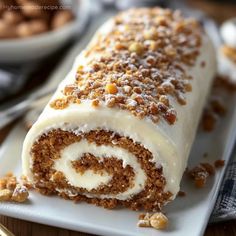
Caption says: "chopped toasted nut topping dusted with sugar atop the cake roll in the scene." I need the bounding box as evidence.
[50,8,202,124]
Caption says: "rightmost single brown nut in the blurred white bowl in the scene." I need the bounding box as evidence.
[52,10,74,29]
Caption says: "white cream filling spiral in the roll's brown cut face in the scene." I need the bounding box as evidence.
[53,140,147,200]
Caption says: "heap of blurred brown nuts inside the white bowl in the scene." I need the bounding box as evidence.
[0,0,74,39]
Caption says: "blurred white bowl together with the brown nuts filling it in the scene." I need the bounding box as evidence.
[0,0,90,63]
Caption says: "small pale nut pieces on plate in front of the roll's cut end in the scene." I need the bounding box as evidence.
[138,212,168,230]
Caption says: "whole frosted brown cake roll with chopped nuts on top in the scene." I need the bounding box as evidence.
[22,8,216,211]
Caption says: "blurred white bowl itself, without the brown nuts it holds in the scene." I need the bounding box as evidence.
[0,0,90,63]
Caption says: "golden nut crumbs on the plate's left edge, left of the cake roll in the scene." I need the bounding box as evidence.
[0,173,29,202]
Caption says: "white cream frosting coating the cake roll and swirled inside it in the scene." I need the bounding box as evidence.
[22,18,216,199]
